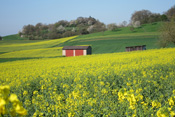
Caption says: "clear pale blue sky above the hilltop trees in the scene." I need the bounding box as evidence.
[0,0,175,36]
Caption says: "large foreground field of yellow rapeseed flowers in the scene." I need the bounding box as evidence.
[0,48,175,117]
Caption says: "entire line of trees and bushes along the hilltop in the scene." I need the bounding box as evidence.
[19,7,175,40]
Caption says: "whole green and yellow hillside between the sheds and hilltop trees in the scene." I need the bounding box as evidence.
[0,22,174,61]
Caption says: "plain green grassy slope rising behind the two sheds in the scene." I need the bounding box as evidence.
[62,22,172,54]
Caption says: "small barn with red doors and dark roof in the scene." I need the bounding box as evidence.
[62,46,92,57]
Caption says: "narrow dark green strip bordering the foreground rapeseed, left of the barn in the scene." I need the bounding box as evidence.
[0,56,63,63]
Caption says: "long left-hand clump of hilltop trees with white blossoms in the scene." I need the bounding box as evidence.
[19,17,106,40]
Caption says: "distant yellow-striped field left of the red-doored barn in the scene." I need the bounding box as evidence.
[0,36,76,62]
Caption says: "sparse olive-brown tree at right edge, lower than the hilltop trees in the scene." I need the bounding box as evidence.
[159,19,175,47]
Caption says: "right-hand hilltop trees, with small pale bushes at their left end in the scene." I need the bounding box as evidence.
[107,6,175,30]
